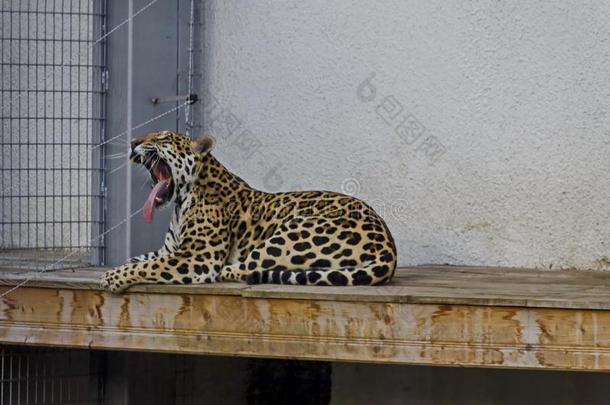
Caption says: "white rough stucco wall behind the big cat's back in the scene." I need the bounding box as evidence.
[204,0,610,269]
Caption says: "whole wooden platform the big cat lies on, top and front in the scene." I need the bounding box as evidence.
[0,266,610,371]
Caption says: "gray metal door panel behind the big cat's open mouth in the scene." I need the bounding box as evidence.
[105,0,203,265]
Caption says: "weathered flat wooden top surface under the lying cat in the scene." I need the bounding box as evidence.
[0,266,610,310]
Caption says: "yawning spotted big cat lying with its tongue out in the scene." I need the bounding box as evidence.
[101,131,396,292]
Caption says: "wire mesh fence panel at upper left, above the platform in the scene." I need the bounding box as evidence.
[0,0,106,267]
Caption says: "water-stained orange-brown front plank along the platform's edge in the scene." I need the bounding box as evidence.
[0,287,610,371]
